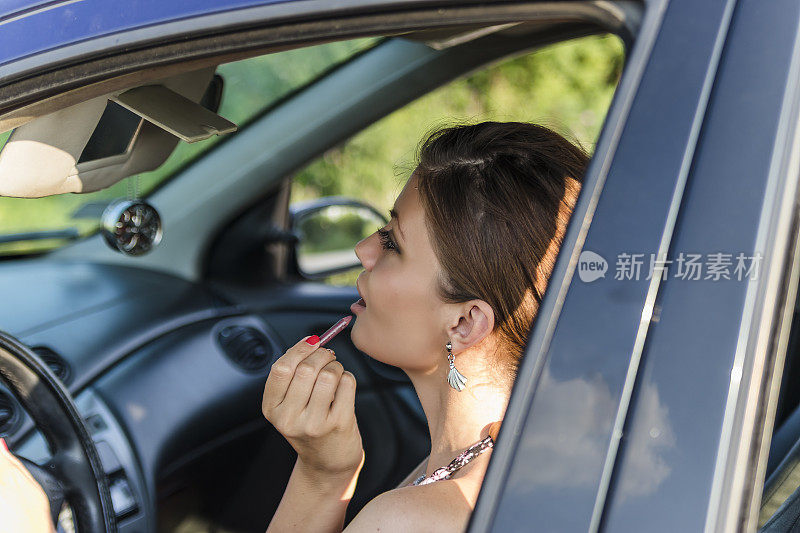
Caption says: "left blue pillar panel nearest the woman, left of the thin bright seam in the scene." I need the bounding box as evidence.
[468,0,752,531]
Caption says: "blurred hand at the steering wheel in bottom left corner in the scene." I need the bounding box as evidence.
[0,439,55,533]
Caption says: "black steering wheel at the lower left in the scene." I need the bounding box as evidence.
[0,331,117,533]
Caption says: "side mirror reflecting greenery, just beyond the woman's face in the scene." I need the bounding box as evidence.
[291,196,388,279]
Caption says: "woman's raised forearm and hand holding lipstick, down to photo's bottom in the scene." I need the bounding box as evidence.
[261,335,365,533]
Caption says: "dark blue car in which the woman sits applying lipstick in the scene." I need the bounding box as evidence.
[0,0,800,533]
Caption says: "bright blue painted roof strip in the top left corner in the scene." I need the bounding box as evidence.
[0,0,302,69]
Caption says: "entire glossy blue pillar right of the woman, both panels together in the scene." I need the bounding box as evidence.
[472,0,800,532]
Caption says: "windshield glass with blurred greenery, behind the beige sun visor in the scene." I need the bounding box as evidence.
[0,38,379,255]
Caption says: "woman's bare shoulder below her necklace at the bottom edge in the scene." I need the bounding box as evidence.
[344,480,473,533]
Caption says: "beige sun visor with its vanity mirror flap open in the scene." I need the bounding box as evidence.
[0,68,236,198]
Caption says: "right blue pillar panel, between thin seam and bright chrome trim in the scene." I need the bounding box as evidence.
[605,0,800,532]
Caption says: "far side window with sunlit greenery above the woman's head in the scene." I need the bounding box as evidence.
[292,34,625,285]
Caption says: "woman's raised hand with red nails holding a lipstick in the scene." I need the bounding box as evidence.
[261,335,364,476]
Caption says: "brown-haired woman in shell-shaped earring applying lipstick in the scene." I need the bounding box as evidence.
[0,122,588,533]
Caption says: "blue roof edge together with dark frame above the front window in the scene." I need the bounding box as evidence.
[0,0,614,87]
